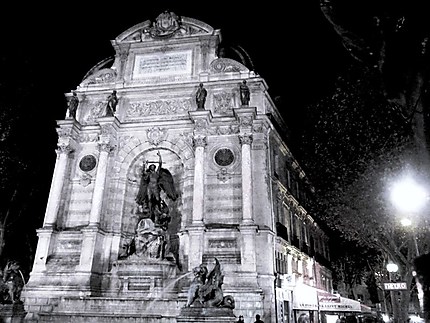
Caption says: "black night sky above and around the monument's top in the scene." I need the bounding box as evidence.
[0,0,347,218]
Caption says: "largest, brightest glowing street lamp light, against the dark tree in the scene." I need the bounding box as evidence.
[391,178,428,212]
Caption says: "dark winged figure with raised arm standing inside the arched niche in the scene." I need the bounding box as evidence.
[135,151,178,230]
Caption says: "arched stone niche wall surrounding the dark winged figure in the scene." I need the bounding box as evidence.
[106,137,194,261]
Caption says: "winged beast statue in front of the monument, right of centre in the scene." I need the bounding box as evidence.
[185,258,235,309]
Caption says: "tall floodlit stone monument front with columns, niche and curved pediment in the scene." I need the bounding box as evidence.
[23,11,277,322]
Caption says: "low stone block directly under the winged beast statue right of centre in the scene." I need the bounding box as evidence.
[176,307,237,323]
